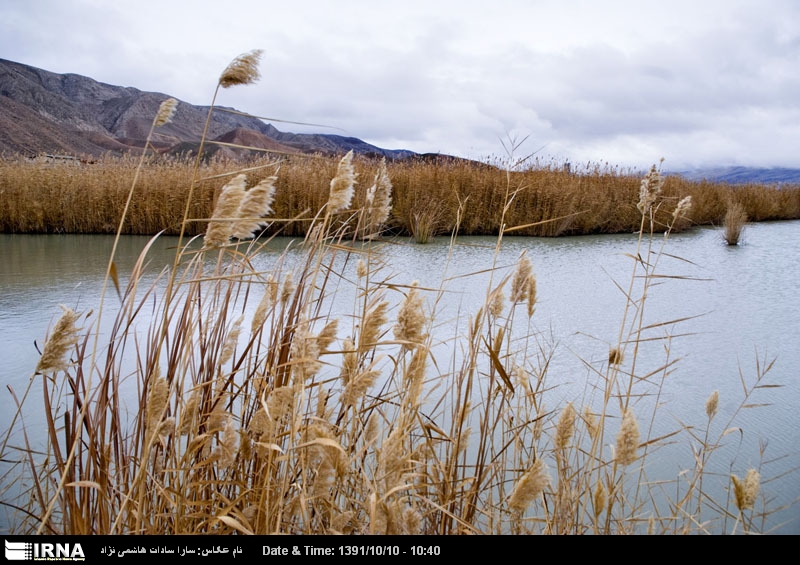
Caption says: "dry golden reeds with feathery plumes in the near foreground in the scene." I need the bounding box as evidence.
[0,49,792,535]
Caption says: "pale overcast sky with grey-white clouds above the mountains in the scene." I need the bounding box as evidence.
[0,0,800,171]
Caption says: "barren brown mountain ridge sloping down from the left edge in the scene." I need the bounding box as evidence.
[0,59,415,159]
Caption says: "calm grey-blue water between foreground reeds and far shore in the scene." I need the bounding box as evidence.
[0,222,800,534]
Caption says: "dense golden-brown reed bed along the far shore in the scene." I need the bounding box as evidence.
[0,154,800,241]
